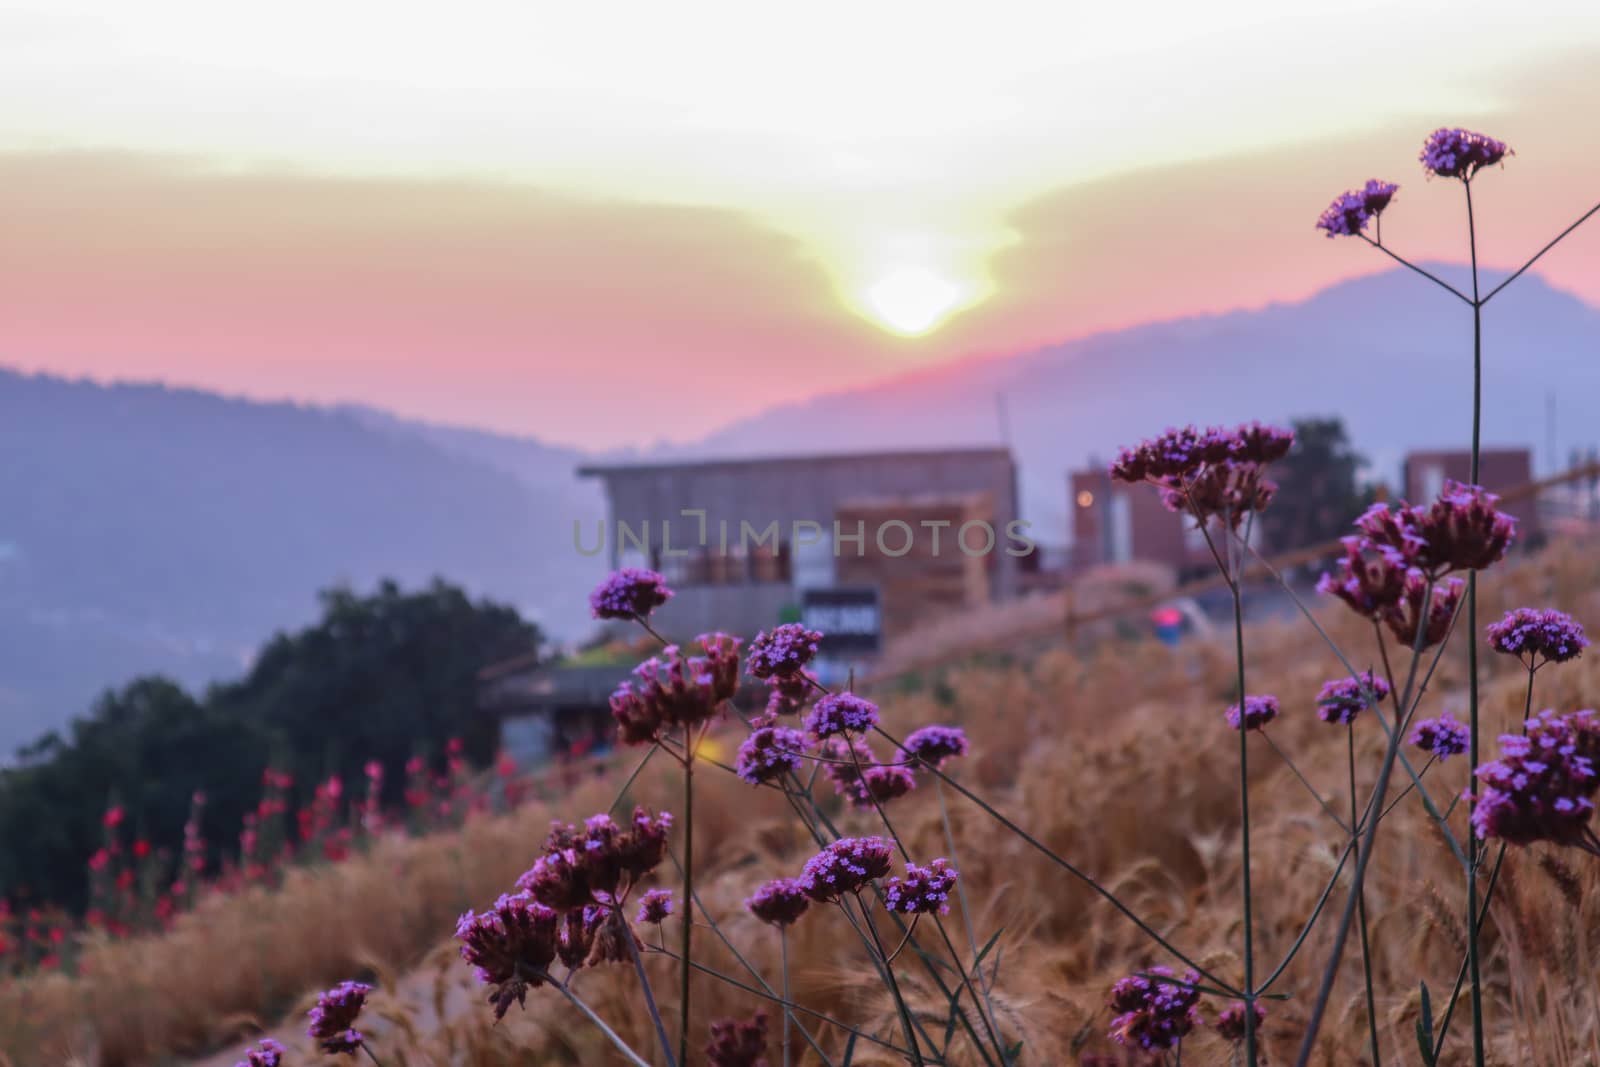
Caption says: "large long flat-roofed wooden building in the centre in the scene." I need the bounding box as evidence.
[576,448,1027,638]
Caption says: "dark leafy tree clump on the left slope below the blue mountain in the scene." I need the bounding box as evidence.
[0,581,541,909]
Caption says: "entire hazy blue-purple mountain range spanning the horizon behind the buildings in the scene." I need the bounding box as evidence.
[0,266,1600,752]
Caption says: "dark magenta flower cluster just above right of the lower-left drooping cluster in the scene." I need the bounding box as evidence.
[517,808,672,912]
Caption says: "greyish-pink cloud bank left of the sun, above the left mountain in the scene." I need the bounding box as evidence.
[0,154,915,445]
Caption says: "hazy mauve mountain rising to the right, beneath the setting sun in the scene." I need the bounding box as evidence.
[678,264,1600,542]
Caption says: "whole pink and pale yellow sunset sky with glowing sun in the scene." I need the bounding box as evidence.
[0,0,1600,448]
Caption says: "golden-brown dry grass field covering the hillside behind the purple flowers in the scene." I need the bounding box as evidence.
[0,544,1600,1067]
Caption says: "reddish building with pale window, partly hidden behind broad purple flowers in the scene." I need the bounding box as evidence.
[1067,466,1216,576]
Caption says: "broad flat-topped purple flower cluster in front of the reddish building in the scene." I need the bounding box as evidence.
[1110,422,1294,528]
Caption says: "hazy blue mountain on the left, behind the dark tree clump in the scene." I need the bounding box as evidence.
[0,371,600,752]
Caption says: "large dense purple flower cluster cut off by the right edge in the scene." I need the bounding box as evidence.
[1472,710,1600,849]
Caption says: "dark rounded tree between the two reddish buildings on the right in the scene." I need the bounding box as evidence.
[1261,418,1368,552]
